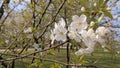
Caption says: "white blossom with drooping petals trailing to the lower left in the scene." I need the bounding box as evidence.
[75,28,96,55]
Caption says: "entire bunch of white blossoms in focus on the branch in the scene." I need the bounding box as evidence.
[51,14,111,55]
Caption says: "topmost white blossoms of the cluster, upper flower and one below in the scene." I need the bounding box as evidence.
[68,15,88,42]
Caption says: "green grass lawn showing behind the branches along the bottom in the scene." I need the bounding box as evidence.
[0,49,120,68]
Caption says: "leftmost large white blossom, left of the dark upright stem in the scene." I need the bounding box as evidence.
[50,18,67,44]
